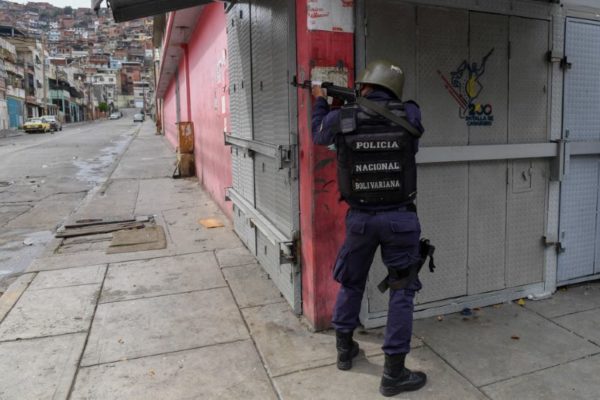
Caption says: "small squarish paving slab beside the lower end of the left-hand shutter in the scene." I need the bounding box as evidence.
[223,264,285,308]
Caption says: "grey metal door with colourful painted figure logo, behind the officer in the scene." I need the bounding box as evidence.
[357,0,549,326]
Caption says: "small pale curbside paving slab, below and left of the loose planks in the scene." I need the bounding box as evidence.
[29,264,106,290]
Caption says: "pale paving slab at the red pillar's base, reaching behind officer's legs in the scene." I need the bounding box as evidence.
[242,303,418,377]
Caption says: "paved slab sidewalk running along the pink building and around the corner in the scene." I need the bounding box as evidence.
[0,122,600,400]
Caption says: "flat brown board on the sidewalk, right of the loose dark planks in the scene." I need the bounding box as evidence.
[106,225,167,254]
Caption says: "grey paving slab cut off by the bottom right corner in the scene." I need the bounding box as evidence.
[482,356,600,400]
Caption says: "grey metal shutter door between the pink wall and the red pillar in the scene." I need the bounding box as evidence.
[226,0,301,312]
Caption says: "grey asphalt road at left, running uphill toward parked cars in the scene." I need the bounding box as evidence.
[0,110,139,292]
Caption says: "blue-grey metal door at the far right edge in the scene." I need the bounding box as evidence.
[558,19,600,284]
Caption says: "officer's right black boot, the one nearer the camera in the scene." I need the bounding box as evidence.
[379,353,427,397]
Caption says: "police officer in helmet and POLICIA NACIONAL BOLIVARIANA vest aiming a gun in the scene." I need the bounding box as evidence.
[312,60,427,396]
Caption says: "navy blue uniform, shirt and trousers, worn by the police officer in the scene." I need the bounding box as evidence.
[312,91,423,355]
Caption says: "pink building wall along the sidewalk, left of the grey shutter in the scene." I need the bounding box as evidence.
[163,3,232,217]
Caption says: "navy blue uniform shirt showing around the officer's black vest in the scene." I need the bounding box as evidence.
[312,90,424,211]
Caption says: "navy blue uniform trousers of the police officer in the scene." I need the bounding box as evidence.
[332,207,421,355]
